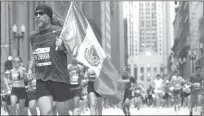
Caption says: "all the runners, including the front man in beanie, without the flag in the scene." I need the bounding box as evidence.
[1,4,204,115]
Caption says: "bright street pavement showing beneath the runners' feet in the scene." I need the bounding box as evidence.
[1,107,200,116]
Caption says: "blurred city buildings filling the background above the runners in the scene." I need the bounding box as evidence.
[0,1,204,89]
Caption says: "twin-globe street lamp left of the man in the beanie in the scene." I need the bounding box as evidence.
[12,24,25,56]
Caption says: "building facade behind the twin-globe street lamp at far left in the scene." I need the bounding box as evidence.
[1,1,40,74]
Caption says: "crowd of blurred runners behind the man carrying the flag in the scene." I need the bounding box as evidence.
[1,57,203,115]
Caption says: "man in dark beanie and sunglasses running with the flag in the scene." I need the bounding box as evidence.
[28,3,71,115]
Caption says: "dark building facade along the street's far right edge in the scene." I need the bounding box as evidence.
[172,1,203,78]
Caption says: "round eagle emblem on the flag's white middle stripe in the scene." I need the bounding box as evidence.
[84,45,100,66]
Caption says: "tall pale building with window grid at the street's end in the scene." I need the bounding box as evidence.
[124,1,174,88]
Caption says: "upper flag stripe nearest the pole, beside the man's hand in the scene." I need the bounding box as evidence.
[60,3,87,54]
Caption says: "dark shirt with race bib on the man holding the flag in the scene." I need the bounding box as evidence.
[30,26,69,83]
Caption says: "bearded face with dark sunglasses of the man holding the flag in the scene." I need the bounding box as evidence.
[35,10,50,29]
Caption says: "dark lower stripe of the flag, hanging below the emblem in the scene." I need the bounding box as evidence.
[94,58,124,104]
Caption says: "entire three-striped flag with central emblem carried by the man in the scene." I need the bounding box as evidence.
[60,2,124,104]
